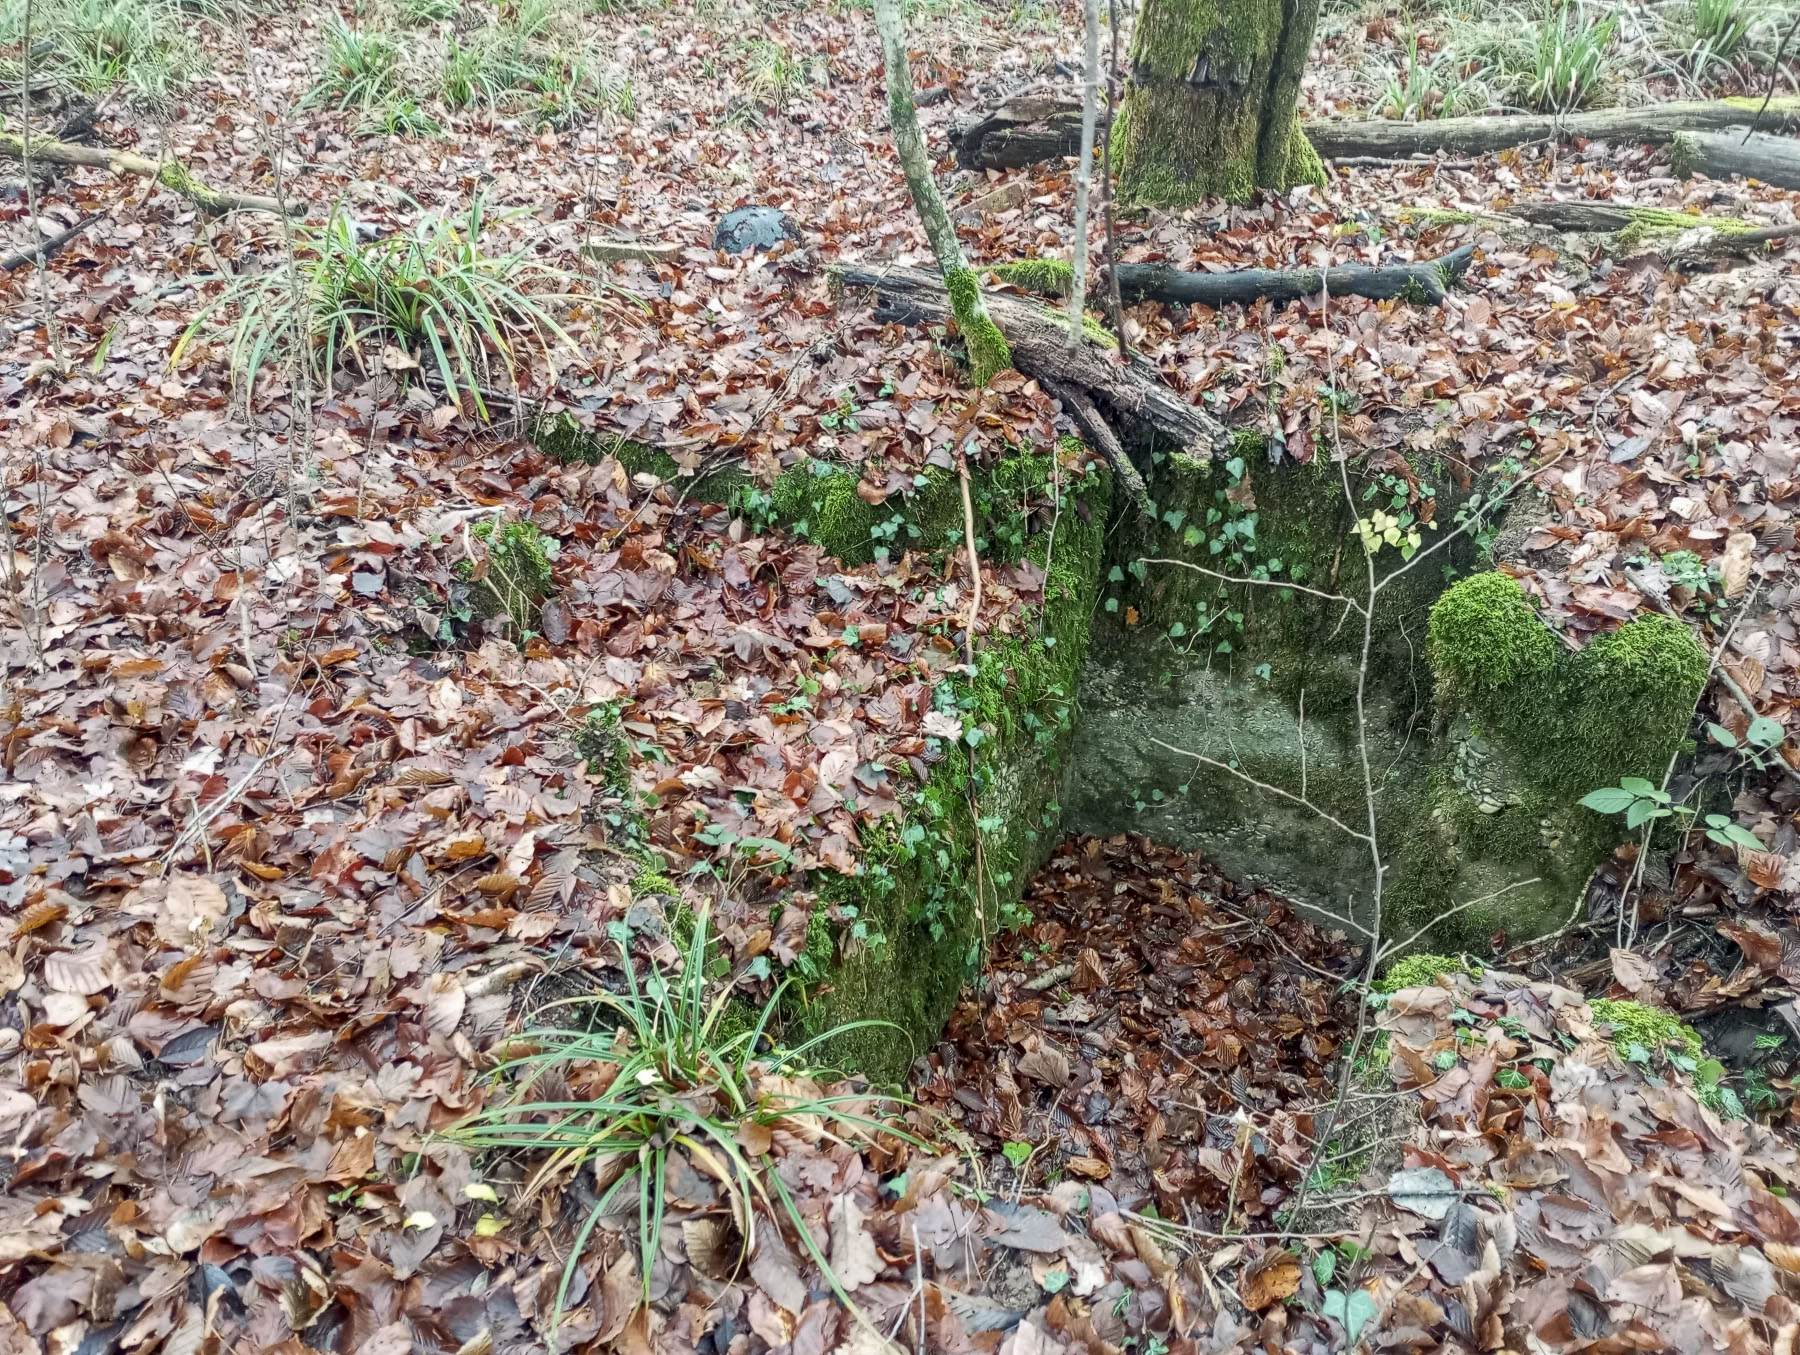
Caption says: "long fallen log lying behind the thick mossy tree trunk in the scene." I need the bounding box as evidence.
[950,97,1800,171]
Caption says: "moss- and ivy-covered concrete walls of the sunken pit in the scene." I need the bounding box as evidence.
[538,416,1706,1078]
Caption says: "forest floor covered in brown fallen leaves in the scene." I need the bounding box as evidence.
[0,0,1800,1355]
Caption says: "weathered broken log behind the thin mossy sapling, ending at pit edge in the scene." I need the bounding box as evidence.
[833,265,1231,461]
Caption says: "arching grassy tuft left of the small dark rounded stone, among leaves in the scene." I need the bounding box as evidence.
[169,196,574,414]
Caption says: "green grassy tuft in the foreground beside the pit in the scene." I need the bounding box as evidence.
[445,909,916,1350]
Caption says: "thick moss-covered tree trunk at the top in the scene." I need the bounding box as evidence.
[1112,0,1323,207]
